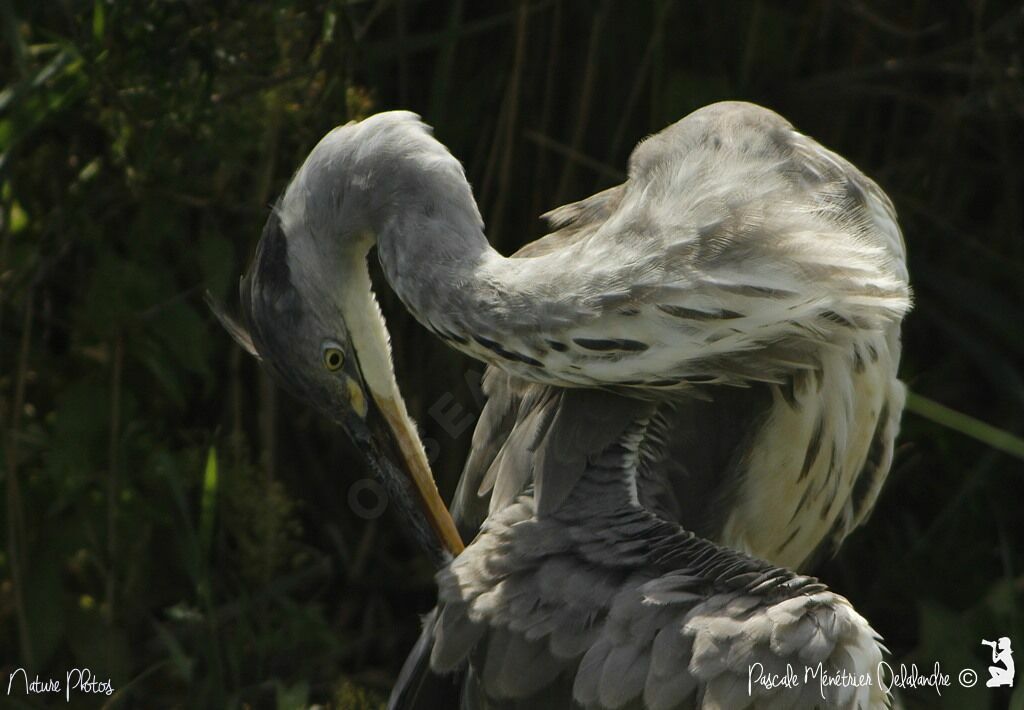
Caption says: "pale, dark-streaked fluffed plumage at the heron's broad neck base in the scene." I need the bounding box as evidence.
[451,102,910,391]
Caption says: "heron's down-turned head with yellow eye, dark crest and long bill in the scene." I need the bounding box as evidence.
[215,120,462,553]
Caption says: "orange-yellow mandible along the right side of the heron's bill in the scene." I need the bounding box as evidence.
[374,396,465,555]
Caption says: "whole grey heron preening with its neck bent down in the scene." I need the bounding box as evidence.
[216,102,909,708]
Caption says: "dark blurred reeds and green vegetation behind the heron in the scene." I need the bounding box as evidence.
[0,0,1024,708]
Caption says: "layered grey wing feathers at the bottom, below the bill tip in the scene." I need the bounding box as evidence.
[428,390,885,709]
